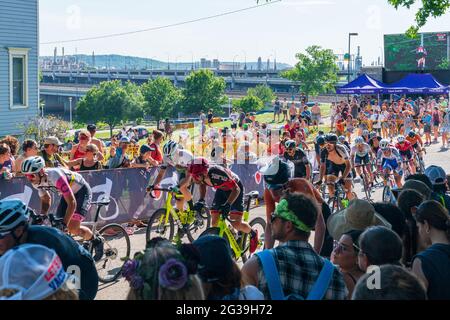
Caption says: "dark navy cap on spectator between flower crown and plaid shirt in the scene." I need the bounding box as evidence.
[192,235,233,282]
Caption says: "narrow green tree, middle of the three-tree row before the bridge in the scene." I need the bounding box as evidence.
[141,77,182,122]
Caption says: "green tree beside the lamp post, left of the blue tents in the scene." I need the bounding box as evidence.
[281,46,338,98]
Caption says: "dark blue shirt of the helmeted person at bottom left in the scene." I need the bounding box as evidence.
[26,226,98,300]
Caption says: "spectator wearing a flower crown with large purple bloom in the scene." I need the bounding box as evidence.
[122,238,205,300]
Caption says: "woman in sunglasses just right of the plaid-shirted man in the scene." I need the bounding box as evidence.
[331,230,364,299]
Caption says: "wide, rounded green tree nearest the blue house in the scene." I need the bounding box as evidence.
[76,80,144,136]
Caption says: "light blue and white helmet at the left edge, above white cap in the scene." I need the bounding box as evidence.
[0,199,29,232]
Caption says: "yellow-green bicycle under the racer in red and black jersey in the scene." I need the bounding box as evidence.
[200,191,266,263]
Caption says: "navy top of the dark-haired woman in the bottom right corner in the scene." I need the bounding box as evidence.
[414,243,450,300]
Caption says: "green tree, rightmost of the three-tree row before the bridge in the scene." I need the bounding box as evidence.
[182,69,227,114]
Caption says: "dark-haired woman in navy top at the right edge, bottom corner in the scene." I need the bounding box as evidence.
[412,200,450,300]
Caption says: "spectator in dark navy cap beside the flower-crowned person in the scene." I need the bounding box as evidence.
[193,235,264,300]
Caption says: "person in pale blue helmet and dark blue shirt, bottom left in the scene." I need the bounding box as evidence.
[0,199,98,300]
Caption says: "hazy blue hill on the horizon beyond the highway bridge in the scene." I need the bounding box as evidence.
[39,54,291,70]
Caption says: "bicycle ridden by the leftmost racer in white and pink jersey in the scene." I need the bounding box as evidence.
[30,199,131,283]
